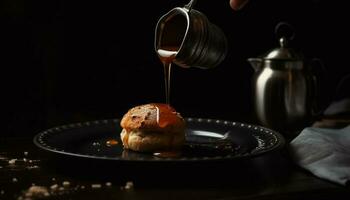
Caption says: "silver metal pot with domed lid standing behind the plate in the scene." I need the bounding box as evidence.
[248,24,322,135]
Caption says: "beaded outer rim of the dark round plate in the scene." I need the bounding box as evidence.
[32,117,286,163]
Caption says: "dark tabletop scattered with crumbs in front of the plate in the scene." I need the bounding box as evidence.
[0,138,350,200]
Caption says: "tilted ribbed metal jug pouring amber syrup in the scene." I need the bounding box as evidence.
[154,1,227,69]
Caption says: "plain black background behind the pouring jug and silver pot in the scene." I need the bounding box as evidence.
[0,0,350,137]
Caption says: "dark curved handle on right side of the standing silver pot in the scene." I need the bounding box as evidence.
[309,58,330,119]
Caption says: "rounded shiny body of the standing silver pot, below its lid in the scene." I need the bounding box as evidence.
[252,61,313,132]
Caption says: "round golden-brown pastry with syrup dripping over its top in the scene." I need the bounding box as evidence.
[120,103,186,152]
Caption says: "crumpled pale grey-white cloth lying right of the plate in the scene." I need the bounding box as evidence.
[290,125,350,185]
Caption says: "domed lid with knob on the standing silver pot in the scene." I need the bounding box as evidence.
[264,37,302,60]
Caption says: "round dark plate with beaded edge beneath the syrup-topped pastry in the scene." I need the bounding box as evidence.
[33,118,285,162]
